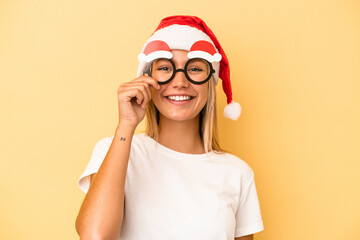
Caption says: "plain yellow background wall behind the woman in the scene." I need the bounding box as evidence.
[0,0,360,240]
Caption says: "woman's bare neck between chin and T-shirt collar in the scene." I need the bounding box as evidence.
[159,116,205,154]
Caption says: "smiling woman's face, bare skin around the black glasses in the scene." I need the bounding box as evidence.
[152,50,209,121]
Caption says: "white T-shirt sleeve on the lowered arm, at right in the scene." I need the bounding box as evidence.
[235,167,264,237]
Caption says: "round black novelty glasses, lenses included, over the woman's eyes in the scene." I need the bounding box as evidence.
[145,58,215,85]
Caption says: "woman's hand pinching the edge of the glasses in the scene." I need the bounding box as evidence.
[117,76,160,129]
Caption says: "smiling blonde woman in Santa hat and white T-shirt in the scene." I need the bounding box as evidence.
[76,16,263,240]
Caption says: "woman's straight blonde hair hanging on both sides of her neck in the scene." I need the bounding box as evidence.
[145,78,227,153]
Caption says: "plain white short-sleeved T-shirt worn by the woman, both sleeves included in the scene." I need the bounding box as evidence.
[78,133,264,240]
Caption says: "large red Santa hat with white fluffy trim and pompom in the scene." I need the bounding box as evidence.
[137,15,241,120]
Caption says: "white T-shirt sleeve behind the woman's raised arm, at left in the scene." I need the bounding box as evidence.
[78,137,113,193]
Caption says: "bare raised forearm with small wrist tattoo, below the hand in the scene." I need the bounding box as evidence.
[76,125,134,239]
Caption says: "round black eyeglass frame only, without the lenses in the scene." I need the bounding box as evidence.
[144,58,216,85]
